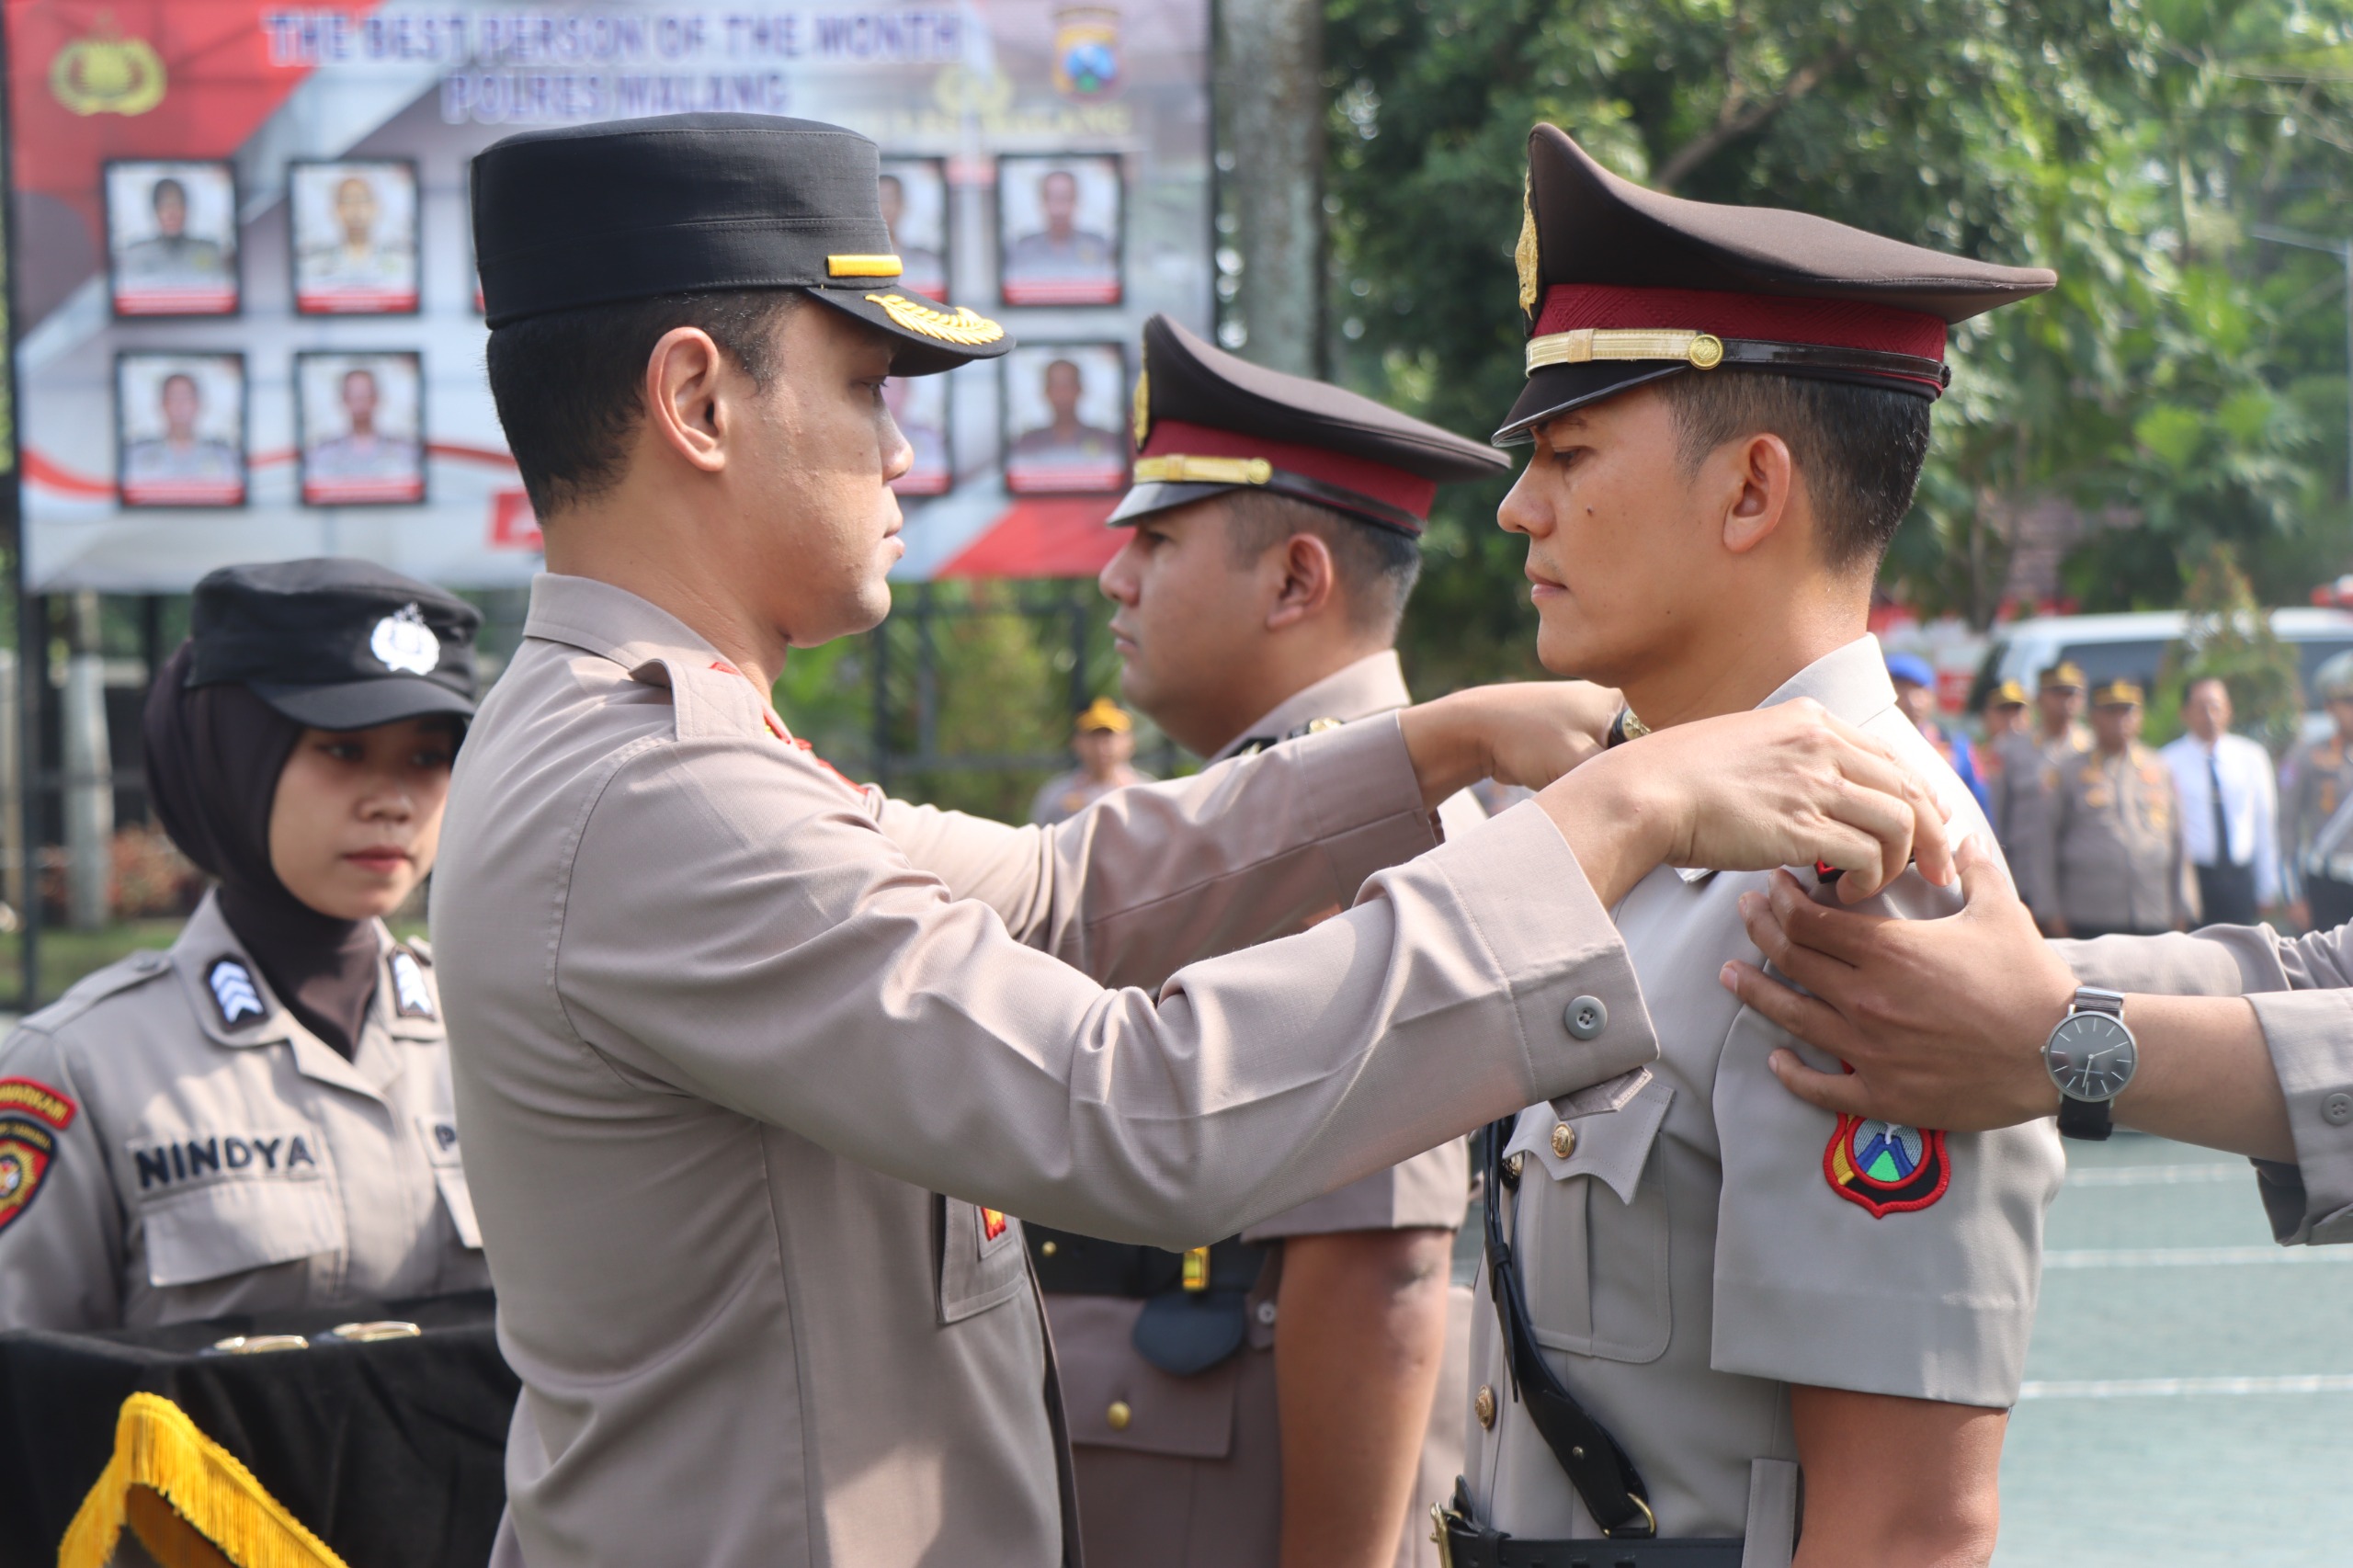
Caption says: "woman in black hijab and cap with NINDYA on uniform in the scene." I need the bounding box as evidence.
[0,561,489,1328]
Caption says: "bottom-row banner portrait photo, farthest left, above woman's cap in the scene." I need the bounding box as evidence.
[115,353,244,506]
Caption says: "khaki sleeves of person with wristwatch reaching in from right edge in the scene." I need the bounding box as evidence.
[2052,926,2353,1245]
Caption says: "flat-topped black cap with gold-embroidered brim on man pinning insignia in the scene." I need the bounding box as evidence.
[473,116,1012,377]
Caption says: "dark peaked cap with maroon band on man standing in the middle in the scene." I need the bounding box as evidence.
[1110,315,1511,534]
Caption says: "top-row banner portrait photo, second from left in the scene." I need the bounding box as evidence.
[287,158,416,315]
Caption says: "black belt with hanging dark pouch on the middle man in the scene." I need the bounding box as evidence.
[1021,1224,1268,1378]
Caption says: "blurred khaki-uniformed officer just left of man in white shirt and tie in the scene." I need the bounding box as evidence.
[2029,680,2198,937]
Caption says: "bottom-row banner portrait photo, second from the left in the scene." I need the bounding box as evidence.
[294,351,426,506]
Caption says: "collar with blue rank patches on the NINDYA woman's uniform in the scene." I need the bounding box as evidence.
[169,892,427,1097]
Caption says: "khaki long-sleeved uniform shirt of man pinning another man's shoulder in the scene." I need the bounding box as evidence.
[433,577,1656,1568]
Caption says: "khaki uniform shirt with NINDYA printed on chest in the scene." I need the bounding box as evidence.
[0,894,489,1328]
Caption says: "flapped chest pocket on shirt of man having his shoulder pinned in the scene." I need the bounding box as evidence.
[1506,1078,1676,1363]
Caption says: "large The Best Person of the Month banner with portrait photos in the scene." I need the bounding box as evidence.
[0,0,1217,594]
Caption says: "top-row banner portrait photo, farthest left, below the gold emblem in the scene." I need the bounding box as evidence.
[106,160,238,315]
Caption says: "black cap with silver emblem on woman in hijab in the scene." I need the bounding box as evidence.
[188,558,483,730]
